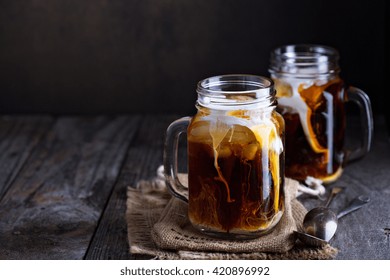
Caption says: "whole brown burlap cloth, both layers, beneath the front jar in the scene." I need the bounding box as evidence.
[126,168,337,260]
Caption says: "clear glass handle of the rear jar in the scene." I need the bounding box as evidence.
[346,86,374,162]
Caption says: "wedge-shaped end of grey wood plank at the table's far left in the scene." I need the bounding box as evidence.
[0,116,54,201]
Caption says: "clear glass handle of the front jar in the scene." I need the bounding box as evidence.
[164,117,191,203]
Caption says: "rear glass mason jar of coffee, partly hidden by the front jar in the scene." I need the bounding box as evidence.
[269,45,373,183]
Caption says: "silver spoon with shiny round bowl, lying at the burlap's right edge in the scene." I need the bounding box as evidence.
[295,195,370,247]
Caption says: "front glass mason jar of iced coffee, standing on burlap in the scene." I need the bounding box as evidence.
[164,75,284,239]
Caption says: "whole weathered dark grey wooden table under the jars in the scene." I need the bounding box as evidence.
[0,115,390,260]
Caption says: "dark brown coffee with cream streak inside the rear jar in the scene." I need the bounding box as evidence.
[275,78,345,182]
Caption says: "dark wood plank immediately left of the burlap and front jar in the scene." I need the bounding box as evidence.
[86,116,179,260]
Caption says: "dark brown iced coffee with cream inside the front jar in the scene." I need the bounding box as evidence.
[188,121,284,236]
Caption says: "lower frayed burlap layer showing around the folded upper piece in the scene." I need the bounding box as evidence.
[126,174,338,260]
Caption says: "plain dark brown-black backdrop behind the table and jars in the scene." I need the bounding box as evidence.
[0,0,389,114]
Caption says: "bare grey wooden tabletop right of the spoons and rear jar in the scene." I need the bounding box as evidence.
[303,116,390,259]
